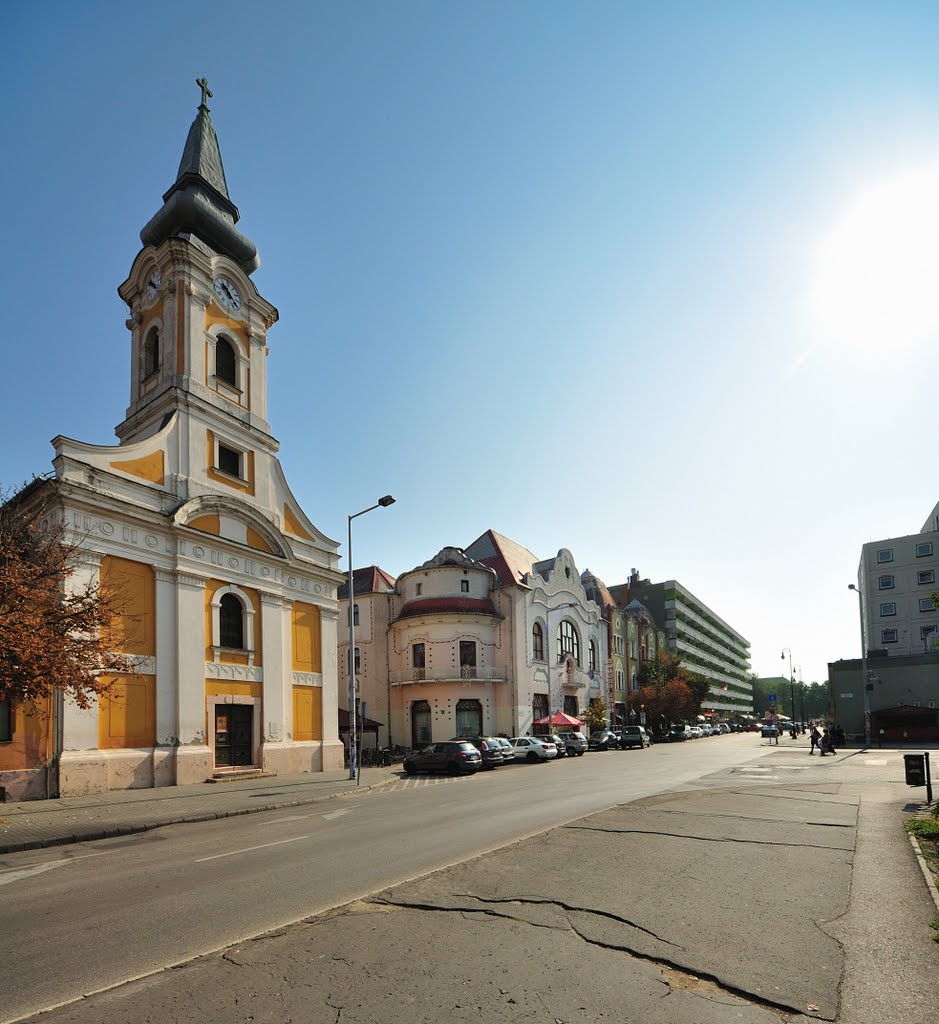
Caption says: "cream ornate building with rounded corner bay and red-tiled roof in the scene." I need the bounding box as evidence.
[340,530,607,746]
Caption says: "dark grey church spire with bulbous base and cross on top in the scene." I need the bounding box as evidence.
[140,78,261,273]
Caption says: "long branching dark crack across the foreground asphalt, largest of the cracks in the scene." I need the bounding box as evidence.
[373,893,834,1021]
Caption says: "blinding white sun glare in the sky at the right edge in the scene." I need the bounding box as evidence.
[812,169,939,354]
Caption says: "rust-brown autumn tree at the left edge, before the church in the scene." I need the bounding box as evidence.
[0,479,132,708]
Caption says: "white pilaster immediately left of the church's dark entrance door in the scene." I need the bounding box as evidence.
[175,572,213,784]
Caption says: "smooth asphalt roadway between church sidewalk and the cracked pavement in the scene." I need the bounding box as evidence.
[0,734,772,1024]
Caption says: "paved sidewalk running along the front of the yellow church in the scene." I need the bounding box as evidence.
[0,765,400,854]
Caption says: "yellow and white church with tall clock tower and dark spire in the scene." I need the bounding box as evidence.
[0,79,343,800]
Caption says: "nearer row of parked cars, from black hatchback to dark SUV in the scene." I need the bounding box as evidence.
[402,725,651,775]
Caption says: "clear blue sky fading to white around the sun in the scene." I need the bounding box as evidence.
[0,0,939,680]
